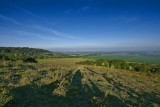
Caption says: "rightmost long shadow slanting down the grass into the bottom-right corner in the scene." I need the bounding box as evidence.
[103,75,160,107]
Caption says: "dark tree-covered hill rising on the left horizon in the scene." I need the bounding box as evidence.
[0,47,53,61]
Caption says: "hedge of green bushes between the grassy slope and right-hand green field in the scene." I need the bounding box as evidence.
[77,59,160,74]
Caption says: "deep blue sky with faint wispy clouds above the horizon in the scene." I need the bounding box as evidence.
[0,0,160,51]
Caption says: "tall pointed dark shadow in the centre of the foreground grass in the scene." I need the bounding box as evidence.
[66,70,91,107]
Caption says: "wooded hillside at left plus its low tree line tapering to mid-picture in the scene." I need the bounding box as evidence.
[0,47,82,61]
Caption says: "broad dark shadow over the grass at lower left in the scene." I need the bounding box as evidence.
[3,81,59,107]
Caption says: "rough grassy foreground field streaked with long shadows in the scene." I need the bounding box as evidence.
[0,58,160,107]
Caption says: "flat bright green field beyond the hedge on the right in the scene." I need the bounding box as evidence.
[86,53,160,64]
